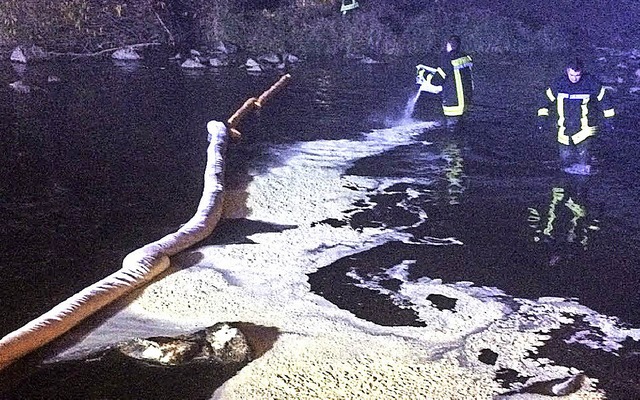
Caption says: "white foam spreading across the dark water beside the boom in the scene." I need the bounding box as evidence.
[58,123,637,399]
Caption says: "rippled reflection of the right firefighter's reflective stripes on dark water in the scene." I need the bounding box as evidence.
[528,186,600,250]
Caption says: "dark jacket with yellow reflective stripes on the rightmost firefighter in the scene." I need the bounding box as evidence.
[538,74,615,145]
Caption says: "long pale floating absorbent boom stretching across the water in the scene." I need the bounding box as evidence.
[0,74,291,371]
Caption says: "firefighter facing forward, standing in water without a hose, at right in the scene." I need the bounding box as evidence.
[538,58,615,175]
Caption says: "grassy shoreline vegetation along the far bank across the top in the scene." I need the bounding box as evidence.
[0,0,640,58]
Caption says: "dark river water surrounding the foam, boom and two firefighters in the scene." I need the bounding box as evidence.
[0,49,640,398]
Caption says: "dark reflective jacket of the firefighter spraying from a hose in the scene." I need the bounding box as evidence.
[431,51,473,117]
